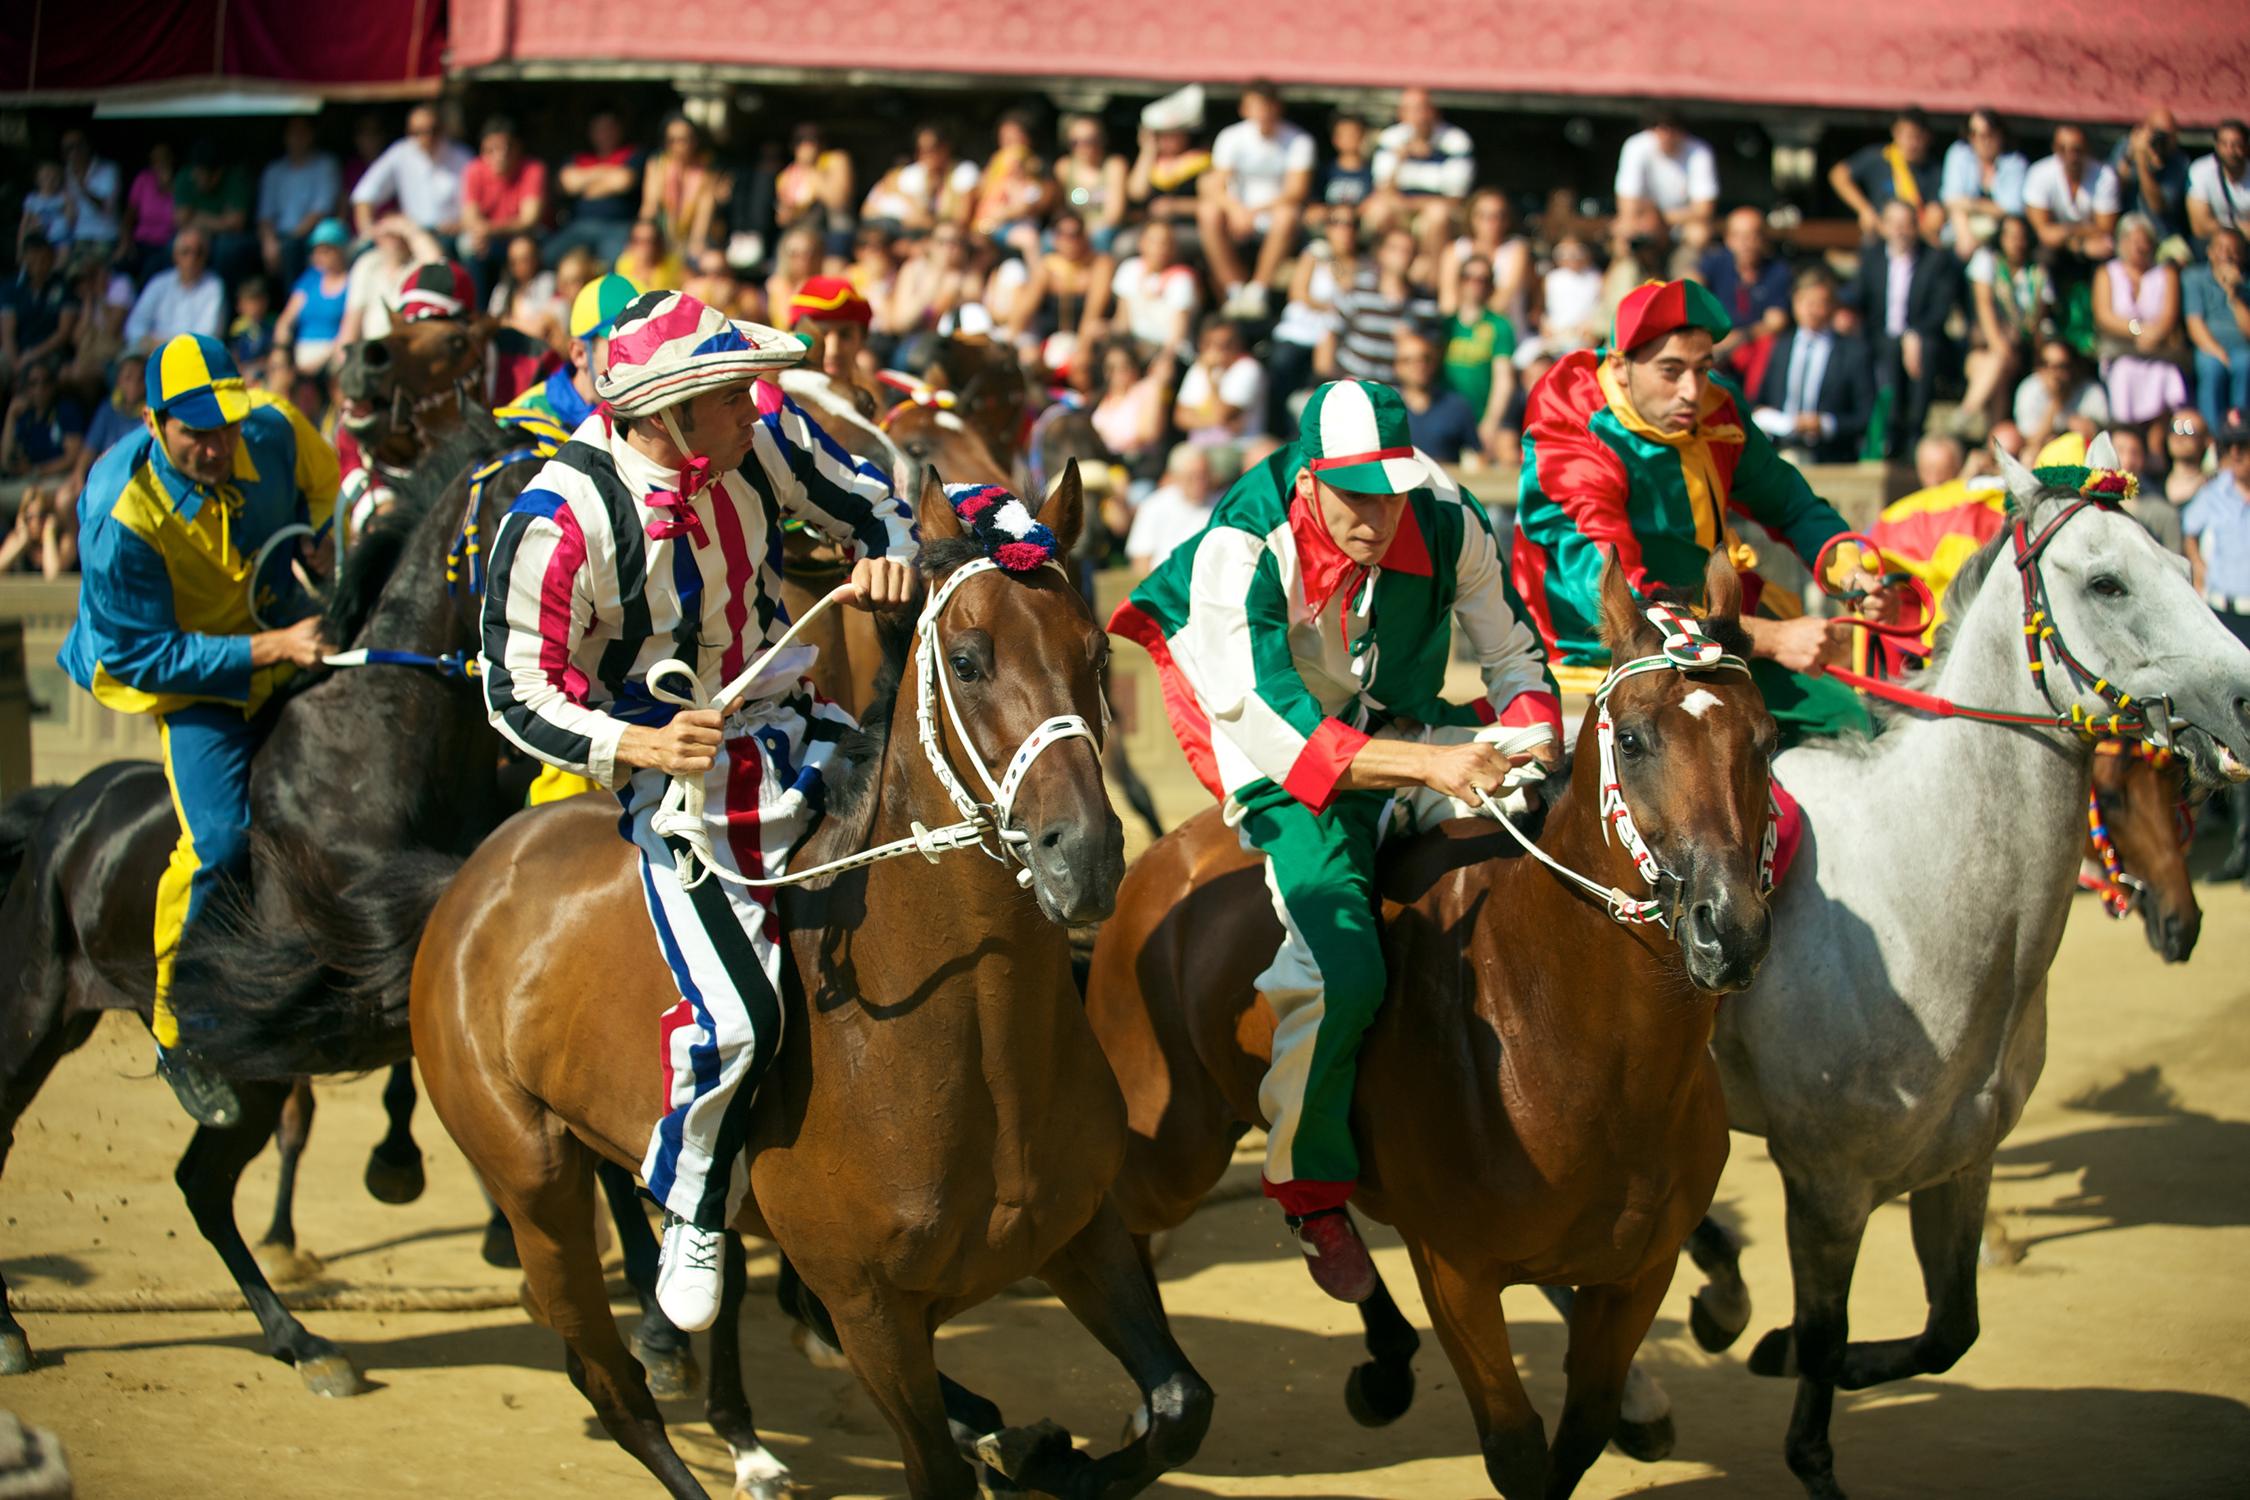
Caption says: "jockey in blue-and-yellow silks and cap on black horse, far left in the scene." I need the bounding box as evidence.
[61,333,338,1124]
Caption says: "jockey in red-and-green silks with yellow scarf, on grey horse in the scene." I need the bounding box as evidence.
[1512,281,1895,740]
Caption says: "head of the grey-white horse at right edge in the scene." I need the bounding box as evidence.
[1978,434,2250,789]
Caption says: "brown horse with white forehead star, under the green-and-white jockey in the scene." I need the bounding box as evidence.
[1087,558,1775,1500]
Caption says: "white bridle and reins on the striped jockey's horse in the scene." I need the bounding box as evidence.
[648,558,1103,891]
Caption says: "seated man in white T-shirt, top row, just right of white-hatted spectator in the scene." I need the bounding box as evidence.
[1195,81,1314,317]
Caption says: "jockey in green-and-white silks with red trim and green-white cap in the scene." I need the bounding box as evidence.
[1109,380,1559,1302]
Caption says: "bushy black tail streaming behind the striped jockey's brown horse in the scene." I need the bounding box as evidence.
[171,846,461,1077]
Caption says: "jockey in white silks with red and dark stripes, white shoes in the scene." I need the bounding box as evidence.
[484,292,918,1329]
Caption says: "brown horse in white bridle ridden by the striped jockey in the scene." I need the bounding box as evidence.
[414,470,1211,1498]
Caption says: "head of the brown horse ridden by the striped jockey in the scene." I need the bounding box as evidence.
[916,463,1125,924]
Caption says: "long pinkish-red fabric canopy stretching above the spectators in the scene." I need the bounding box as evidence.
[452,0,2250,124]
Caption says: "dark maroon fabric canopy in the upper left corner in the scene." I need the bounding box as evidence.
[0,0,448,94]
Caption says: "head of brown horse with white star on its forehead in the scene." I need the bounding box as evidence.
[1580,551,1780,994]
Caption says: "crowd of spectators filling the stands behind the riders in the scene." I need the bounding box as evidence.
[0,83,2250,584]
